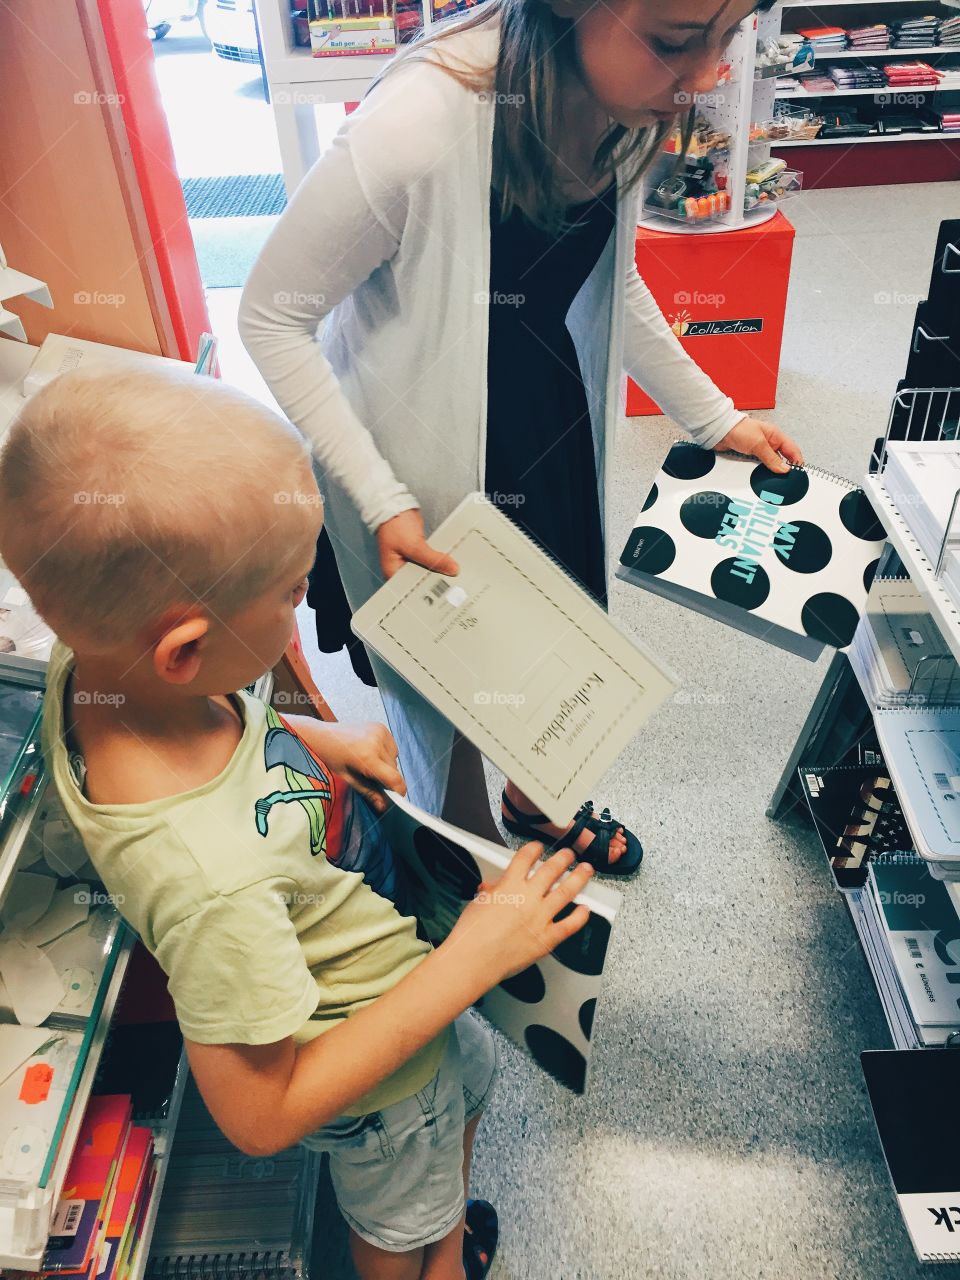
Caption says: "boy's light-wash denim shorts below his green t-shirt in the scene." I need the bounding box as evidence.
[302,1012,497,1253]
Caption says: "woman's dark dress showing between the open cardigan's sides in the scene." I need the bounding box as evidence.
[485,184,617,608]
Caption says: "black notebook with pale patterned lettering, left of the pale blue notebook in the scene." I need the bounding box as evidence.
[797,764,913,891]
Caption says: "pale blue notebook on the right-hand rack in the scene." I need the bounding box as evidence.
[874,707,960,879]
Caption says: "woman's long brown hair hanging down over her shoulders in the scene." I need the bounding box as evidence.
[386,0,774,232]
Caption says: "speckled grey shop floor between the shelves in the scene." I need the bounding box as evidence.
[216,183,960,1280]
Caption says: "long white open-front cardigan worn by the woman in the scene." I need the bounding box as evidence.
[239,12,745,812]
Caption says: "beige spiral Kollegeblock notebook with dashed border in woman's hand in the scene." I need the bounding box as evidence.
[352,494,676,824]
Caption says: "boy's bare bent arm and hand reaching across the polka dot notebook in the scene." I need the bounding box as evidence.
[187,844,593,1156]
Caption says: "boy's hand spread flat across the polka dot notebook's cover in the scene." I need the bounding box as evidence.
[442,841,594,992]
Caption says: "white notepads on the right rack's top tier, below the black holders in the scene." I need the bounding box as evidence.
[883,440,960,602]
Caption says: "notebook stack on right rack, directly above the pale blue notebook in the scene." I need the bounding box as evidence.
[850,577,960,707]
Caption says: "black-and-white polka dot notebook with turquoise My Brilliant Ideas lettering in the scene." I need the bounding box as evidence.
[617,443,884,660]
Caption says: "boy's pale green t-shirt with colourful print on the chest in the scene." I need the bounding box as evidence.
[42,643,447,1115]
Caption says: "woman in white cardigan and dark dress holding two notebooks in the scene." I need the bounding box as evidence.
[239,0,803,874]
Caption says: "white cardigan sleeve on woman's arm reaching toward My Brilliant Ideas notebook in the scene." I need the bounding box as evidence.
[623,257,746,449]
